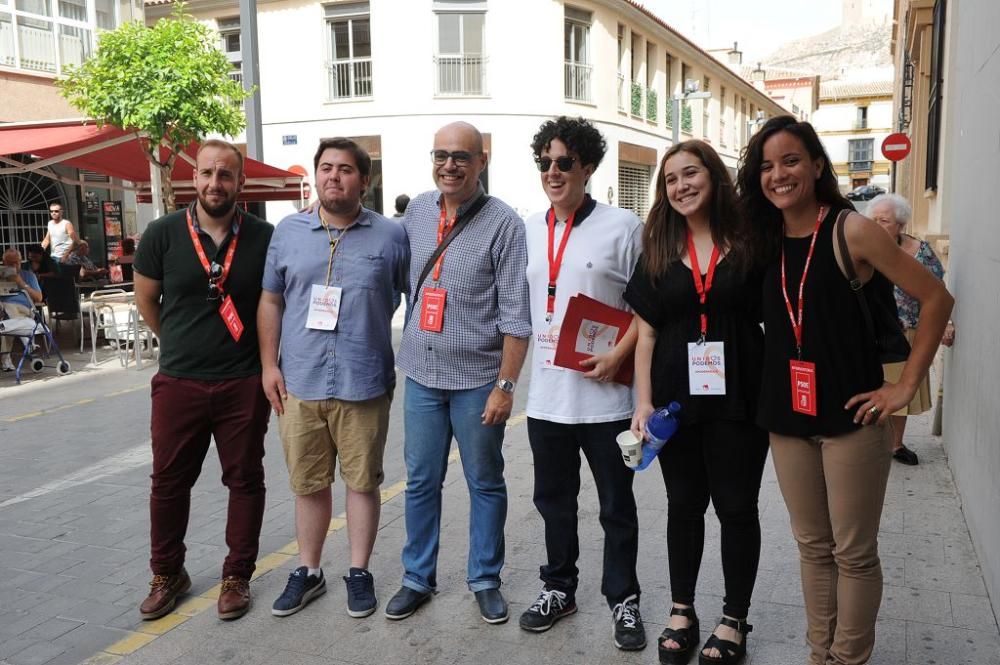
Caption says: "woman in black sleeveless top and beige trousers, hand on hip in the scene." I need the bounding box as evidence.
[738,116,953,665]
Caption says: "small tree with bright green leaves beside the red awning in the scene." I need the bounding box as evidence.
[58,2,252,210]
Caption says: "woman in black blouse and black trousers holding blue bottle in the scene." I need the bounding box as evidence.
[625,141,767,665]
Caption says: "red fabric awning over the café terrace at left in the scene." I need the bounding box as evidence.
[0,120,303,203]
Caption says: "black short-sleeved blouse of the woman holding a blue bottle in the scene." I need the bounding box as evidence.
[625,252,764,425]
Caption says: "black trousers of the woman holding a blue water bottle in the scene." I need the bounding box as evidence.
[659,421,768,619]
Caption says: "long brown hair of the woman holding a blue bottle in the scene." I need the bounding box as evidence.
[642,140,752,282]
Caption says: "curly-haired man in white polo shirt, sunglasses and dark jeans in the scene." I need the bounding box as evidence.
[520,117,646,650]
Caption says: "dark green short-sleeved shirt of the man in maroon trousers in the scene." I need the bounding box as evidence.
[134,210,274,381]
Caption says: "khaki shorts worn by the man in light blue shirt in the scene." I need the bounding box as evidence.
[278,393,392,496]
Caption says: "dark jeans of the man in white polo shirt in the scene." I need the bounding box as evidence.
[528,418,639,607]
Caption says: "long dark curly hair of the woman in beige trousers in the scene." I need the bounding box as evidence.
[736,115,854,261]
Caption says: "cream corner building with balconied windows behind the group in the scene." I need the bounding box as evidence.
[146,0,783,220]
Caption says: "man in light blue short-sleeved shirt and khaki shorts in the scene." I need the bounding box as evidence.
[257,138,410,618]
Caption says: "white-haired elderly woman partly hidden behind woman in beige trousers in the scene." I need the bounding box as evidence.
[868,194,955,466]
